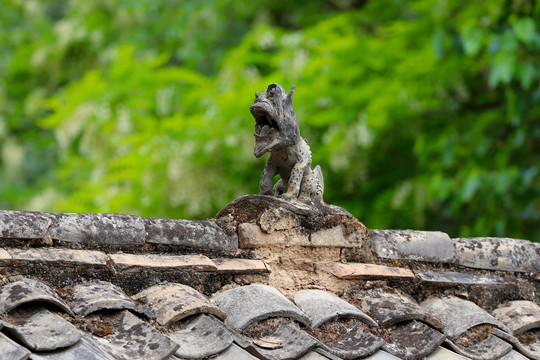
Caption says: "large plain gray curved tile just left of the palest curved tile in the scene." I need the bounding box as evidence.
[213,285,309,332]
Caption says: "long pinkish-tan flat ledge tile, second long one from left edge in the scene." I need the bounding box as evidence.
[108,254,217,271]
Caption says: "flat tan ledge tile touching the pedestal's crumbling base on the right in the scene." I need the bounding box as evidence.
[329,262,415,280]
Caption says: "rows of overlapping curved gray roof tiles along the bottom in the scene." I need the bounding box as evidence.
[0,278,540,360]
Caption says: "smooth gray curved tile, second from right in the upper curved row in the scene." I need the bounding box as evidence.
[420,296,510,340]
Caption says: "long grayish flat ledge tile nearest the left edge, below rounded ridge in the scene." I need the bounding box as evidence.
[7,248,109,266]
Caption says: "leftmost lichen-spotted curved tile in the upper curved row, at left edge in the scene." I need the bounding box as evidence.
[0,278,73,314]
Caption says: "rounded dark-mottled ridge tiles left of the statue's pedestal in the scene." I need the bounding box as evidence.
[0,210,238,254]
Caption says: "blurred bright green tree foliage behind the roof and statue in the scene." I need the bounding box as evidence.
[0,0,540,241]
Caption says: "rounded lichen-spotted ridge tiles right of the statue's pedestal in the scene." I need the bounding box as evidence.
[367,230,540,273]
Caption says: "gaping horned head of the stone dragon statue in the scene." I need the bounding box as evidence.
[249,84,300,158]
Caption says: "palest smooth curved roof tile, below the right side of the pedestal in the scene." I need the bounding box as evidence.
[294,290,377,328]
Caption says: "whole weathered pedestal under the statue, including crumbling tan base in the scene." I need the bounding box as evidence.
[214,195,374,293]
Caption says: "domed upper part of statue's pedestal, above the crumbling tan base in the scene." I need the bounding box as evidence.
[215,195,369,249]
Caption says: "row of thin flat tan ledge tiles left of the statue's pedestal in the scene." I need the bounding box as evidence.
[0,247,269,286]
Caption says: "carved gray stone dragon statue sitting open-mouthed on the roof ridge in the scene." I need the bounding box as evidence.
[249,84,324,203]
